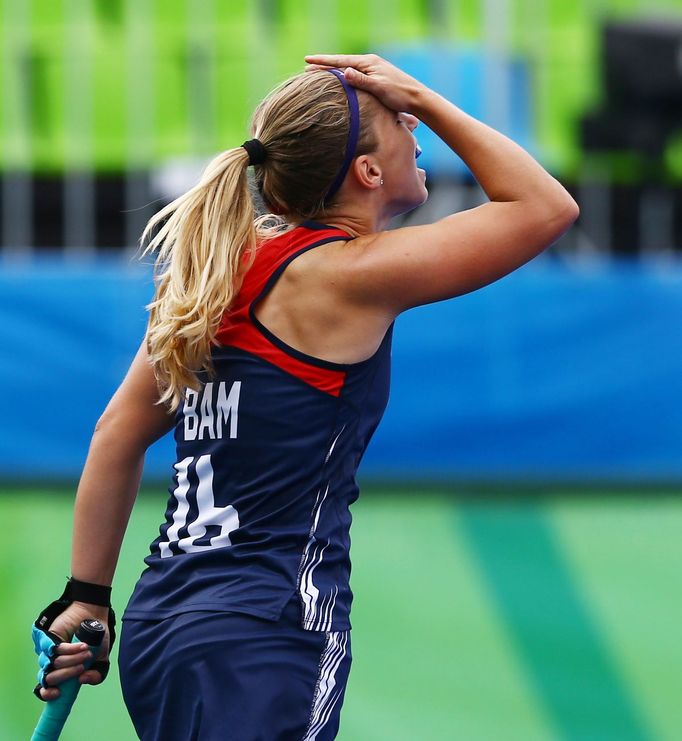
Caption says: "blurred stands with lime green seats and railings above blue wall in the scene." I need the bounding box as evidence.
[0,0,682,257]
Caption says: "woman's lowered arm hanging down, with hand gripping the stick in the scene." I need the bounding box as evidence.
[34,343,172,700]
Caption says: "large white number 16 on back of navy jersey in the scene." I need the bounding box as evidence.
[159,455,239,558]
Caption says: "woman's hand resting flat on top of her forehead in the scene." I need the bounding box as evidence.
[305,54,425,113]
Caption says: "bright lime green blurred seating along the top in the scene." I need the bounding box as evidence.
[5,0,682,175]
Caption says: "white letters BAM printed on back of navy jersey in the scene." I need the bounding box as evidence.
[182,381,242,440]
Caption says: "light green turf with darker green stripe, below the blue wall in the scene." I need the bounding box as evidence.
[0,488,682,741]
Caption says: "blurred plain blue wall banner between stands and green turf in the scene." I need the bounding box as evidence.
[0,259,682,481]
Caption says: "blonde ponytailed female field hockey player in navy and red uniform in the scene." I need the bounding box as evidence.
[30,55,577,741]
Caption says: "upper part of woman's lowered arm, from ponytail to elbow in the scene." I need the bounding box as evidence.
[93,342,174,453]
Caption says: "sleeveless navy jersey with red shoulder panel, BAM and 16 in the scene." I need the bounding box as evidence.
[125,222,392,631]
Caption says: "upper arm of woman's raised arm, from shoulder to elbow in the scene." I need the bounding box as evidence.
[343,201,577,315]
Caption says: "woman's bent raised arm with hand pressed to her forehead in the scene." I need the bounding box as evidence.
[306,55,578,314]
